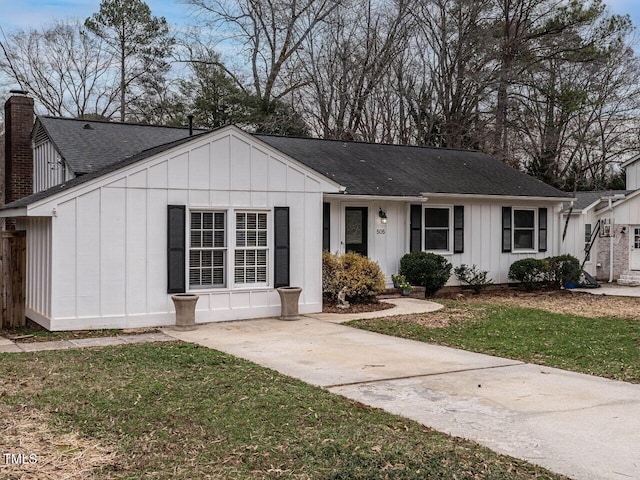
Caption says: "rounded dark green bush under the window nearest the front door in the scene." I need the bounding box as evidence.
[400,252,451,298]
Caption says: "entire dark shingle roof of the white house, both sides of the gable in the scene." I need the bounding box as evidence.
[0,124,571,210]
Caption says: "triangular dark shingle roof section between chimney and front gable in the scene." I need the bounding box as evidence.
[38,116,204,175]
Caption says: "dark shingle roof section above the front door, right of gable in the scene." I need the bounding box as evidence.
[257,135,570,198]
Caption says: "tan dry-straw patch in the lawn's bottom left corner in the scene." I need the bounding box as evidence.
[0,405,116,480]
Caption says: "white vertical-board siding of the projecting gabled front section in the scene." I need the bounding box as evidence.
[34,128,337,330]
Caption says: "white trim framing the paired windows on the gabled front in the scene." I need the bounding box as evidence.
[185,205,274,293]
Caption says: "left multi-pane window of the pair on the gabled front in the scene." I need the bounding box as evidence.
[189,211,227,288]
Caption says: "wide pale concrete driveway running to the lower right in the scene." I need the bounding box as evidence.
[165,317,640,480]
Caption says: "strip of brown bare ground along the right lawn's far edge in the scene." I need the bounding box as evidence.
[436,289,640,320]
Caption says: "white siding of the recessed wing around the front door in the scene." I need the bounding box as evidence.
[325,197,560,285]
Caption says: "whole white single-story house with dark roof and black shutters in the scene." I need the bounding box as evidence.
[0,97,571,330]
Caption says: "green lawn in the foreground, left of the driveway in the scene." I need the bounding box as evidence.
[0,343,564,480]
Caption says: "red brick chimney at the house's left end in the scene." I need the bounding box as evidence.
[0,90,34,205]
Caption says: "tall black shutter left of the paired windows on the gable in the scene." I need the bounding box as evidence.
[167,205,187,293]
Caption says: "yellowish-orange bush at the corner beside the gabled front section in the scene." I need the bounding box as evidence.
[322,252,385,303]
